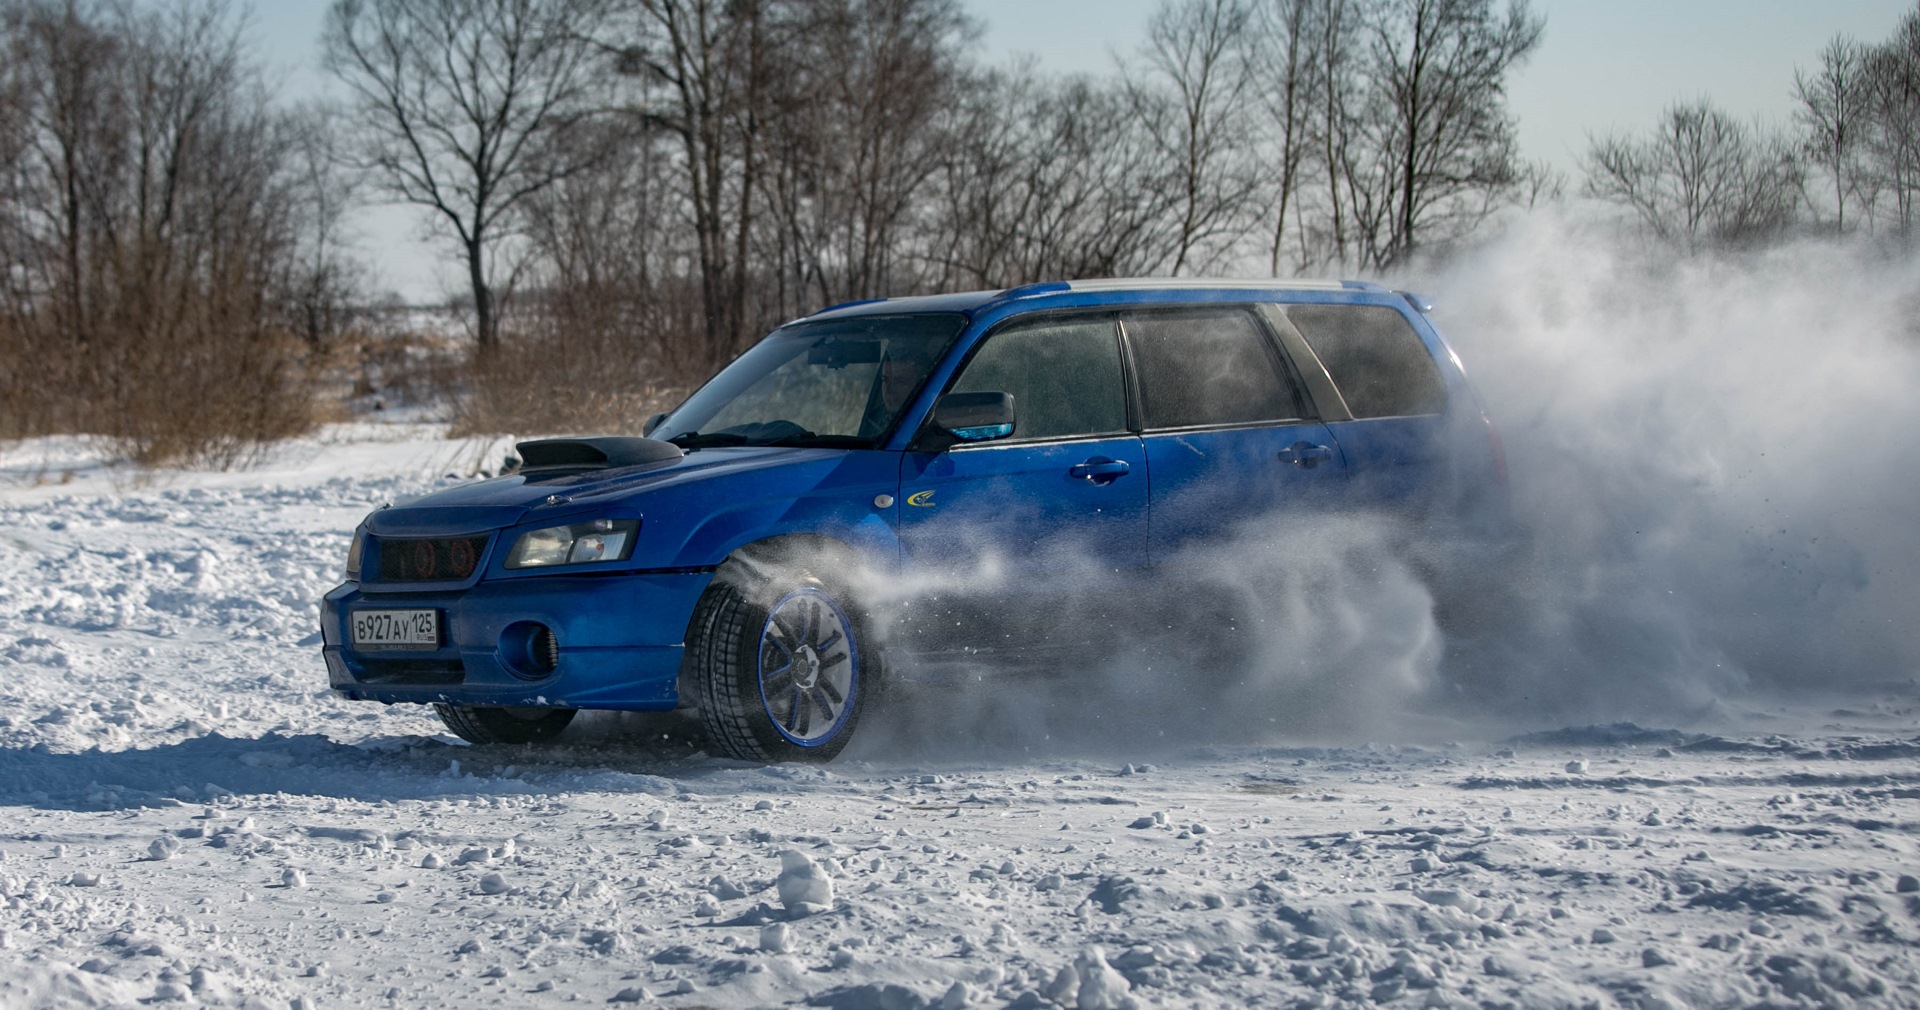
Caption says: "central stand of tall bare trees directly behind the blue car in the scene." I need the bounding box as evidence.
[324,0,1542,432]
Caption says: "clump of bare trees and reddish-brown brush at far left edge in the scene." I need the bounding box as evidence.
[0,0,311,465]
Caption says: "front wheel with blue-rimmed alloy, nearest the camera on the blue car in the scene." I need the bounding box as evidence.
[687,565,877,762]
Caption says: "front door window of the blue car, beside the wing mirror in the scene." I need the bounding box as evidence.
[952,319,1127,440]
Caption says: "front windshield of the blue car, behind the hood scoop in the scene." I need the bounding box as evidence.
[653,313,966,449]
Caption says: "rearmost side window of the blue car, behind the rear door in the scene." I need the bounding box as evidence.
[1286,305,1446,417]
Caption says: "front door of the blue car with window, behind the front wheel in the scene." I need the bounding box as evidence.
[897,313,1148,651]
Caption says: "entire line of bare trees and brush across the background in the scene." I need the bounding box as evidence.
[0,0,1920,463]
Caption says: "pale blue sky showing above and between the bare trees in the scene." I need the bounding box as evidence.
[253,0,1916,298]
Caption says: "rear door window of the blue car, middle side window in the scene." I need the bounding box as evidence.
[1125,309,1302,428]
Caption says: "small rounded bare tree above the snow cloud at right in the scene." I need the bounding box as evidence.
[1586,100,1801,252]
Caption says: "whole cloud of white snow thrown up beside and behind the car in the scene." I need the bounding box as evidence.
[856,217,1920,755]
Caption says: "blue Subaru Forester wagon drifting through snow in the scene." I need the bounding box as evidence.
[323,280,1505,760]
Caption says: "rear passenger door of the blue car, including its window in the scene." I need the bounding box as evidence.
[1121,305,1346,565]
